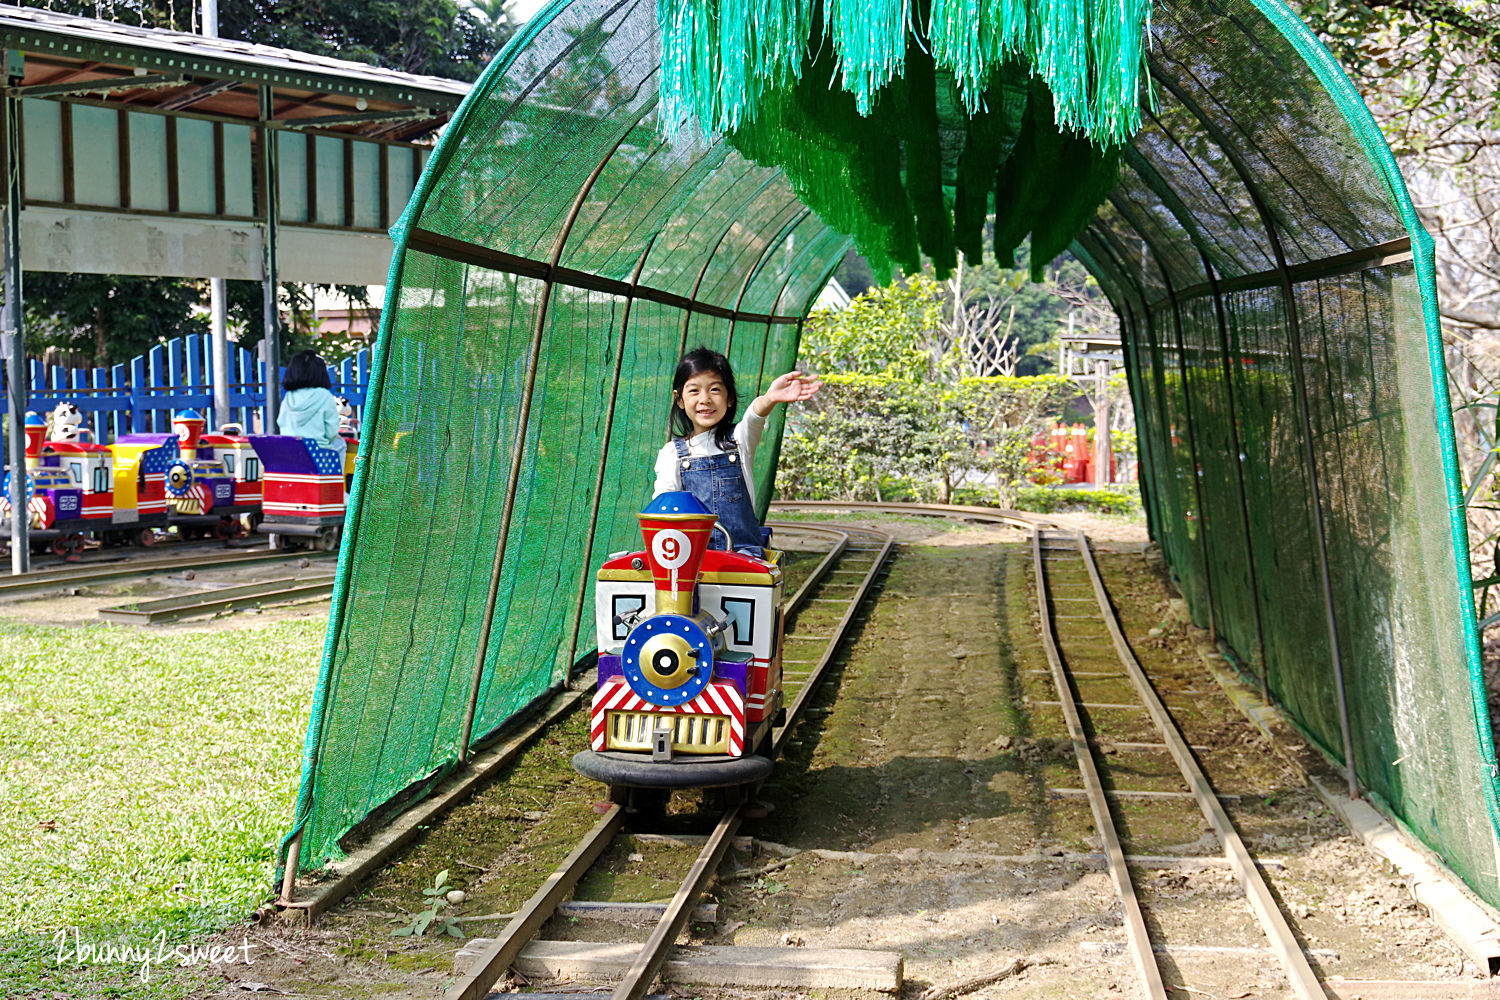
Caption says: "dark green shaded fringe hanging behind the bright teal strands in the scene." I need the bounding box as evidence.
[729,20,1119,283]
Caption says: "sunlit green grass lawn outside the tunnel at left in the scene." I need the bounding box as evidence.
[0,618,324,997]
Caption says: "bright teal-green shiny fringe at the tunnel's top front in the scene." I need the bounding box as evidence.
[657,0,1151,147]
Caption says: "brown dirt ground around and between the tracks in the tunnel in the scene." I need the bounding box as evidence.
[108,516,1500,1000]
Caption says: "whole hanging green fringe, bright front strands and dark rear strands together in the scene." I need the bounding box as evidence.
[684,0,1149,282]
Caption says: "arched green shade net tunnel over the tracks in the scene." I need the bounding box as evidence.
[282,0,1500,904]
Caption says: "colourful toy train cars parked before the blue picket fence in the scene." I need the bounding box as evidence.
[0,403,359,556]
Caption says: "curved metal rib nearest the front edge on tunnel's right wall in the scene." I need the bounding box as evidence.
[1149,60,1361,799]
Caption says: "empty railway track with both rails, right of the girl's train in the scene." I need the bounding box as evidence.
[1032,529,1326,1000]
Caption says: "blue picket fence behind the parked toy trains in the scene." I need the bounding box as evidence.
[26,336,369,442]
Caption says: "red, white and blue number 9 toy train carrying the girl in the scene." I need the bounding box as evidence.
[573,493,782,789]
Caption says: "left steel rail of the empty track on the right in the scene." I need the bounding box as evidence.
[1032,531,1167,1000]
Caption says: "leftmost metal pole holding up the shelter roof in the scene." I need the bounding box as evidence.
[0,96,32,574]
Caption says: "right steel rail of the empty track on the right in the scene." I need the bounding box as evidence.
[1074,531,1325,1000]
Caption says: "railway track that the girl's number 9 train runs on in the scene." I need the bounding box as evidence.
[444,525,896,1000]
